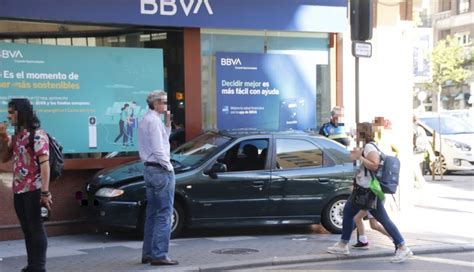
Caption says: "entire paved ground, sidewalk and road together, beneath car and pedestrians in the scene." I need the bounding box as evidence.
[0,173,474,271]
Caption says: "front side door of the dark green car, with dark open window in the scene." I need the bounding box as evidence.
[190,138,271,219]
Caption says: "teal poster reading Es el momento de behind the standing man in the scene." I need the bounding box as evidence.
[0,43,164,153]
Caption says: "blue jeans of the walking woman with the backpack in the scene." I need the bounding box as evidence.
[341,192,405,248]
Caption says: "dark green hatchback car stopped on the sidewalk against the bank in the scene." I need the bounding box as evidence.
[85,132,354,237]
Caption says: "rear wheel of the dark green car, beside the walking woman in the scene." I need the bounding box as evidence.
[321,196,348,234]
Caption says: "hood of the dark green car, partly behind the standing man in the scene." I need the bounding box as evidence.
[91,160,189,187]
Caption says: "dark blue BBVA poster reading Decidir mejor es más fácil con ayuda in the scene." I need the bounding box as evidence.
[216,53,316,131]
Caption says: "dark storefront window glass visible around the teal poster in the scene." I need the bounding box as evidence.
[0,20,184,158]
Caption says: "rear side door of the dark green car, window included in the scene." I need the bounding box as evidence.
[270,137,344,217]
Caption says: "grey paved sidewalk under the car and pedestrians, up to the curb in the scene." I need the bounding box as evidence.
[0,178,474,271]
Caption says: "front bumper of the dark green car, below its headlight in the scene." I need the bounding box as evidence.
[83,193,141,228]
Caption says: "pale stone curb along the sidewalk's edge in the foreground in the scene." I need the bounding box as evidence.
[155,244,474,271]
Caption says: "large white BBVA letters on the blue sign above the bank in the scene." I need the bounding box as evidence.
[140,0,214,17]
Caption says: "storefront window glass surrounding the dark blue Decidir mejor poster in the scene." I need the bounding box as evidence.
[201,29,331,129]
